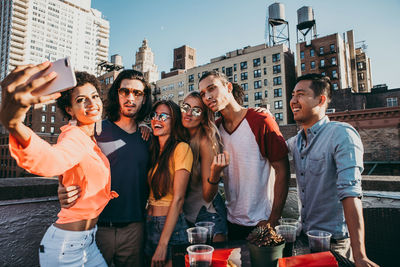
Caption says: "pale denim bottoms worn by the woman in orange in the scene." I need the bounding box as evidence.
[39,225,107,267]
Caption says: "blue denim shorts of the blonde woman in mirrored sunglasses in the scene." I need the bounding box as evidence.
[196,194,228,235]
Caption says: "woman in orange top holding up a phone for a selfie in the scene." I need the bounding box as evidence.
[0,62,117,266]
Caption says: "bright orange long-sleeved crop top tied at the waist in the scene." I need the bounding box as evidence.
[9,125,118,224]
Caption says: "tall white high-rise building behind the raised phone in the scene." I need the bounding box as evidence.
[0,0,110,79]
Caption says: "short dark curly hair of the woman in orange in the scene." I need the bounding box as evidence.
[56,71,100,120]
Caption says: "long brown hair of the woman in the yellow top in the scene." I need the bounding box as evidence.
[148,100,189,200]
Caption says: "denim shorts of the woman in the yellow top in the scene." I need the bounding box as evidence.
[144,213,188,260]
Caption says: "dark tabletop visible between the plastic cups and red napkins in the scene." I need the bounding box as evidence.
[172,239,354,267]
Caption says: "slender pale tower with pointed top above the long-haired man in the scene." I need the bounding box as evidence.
[132,39,158,83]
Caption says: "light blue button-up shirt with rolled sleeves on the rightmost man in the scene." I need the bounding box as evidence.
[287,116,364,239]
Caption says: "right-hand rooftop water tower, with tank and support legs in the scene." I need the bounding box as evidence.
[297,6,317,43]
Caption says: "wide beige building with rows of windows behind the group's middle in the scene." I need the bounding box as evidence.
[153,44,295,124]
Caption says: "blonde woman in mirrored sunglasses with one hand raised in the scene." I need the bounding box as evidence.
[181,91,229,242]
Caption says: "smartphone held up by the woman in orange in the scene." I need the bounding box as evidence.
[29,57,76,96]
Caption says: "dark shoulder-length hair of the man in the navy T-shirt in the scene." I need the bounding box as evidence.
[105,70,152,122]
